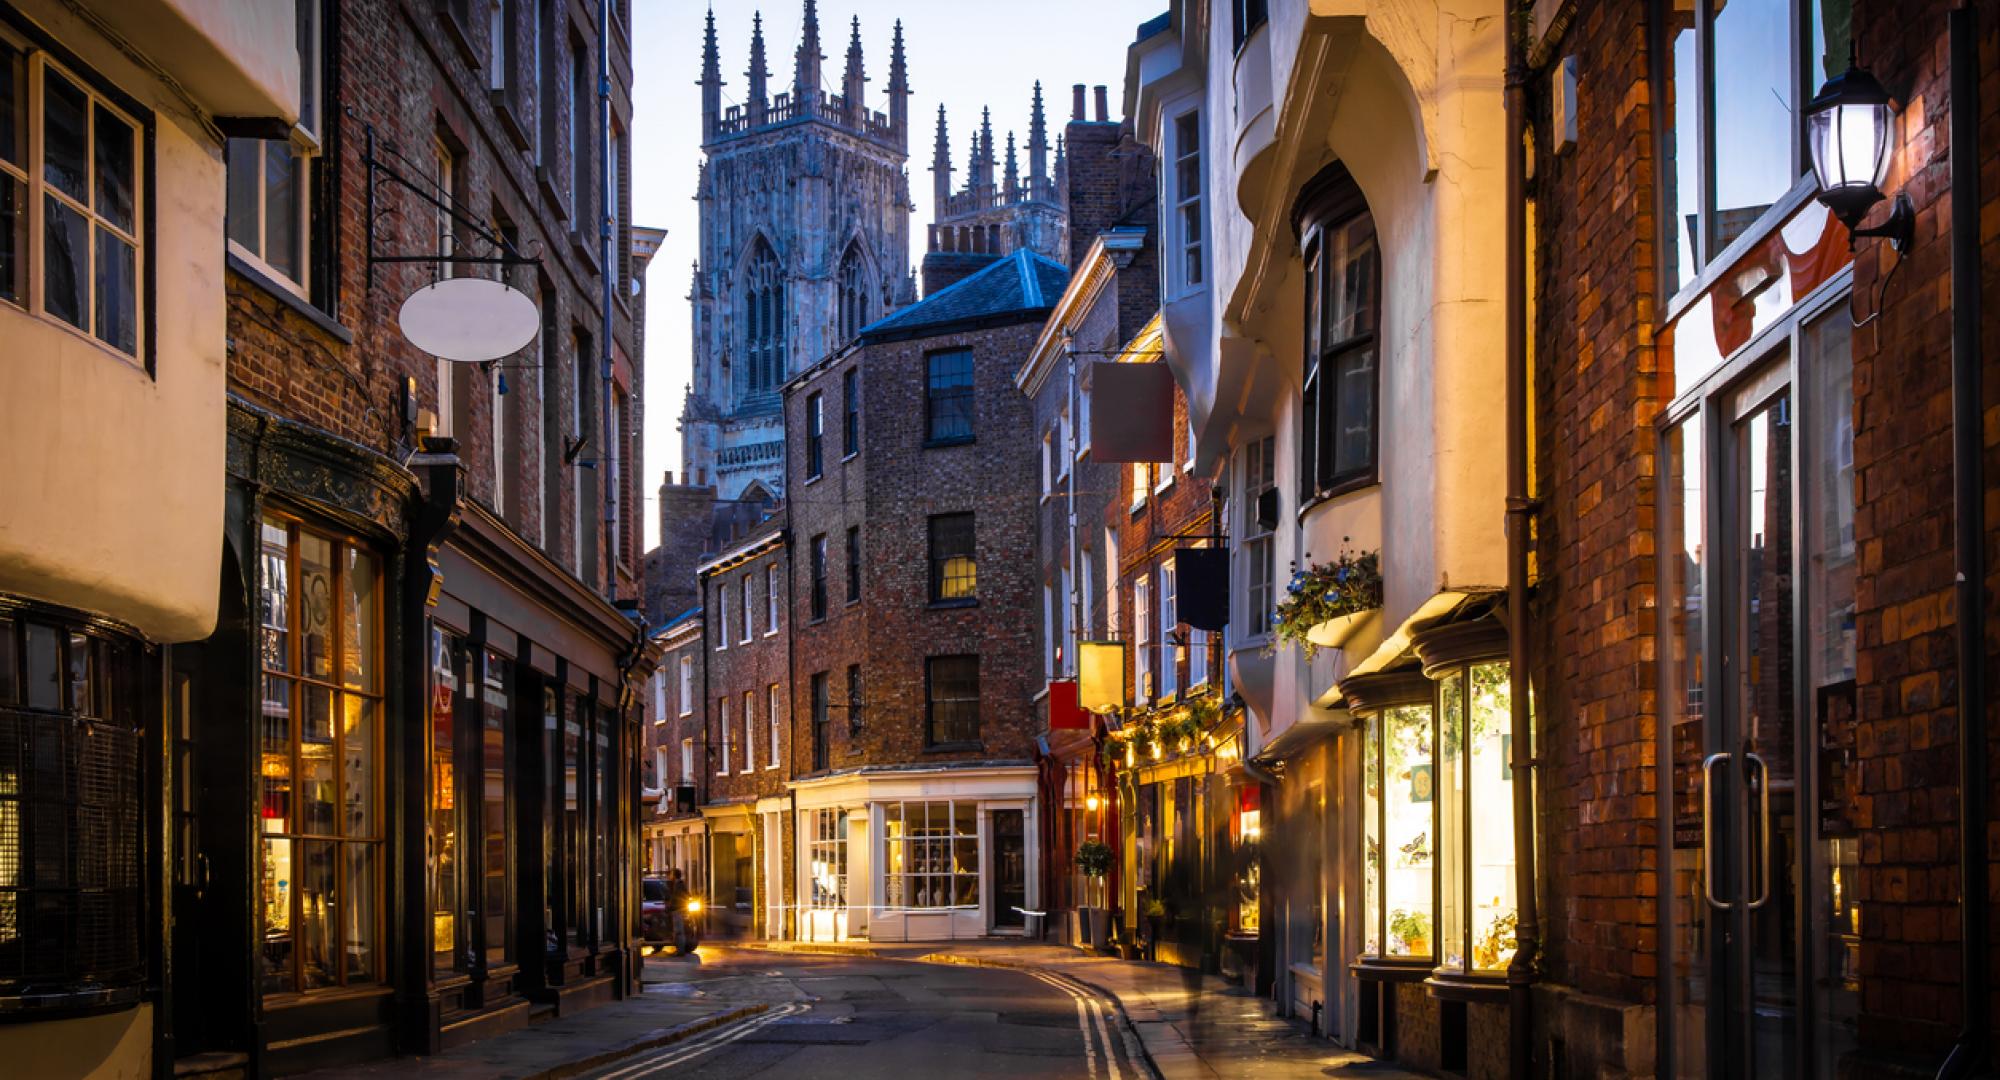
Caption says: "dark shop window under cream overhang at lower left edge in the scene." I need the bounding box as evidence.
[0,610,146,1012]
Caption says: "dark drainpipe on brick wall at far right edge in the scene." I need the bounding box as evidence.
[1938,4,1990,1080]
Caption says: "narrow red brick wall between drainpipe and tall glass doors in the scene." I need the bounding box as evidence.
[1532,2,1672,1020]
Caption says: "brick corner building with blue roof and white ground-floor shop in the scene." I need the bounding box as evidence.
[786,250,1068,940]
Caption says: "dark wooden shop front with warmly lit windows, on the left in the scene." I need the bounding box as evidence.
[168,412,638,1074]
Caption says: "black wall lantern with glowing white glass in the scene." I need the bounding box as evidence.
[1806,66,1916,252]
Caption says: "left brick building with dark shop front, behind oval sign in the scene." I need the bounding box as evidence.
[172,0,656,1074]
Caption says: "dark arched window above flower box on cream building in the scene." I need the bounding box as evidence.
[1298,162,1380,502]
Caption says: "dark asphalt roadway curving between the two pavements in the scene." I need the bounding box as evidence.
[584,946,1146,1080]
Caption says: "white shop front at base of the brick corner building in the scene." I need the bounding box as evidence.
[792,764,1044,942]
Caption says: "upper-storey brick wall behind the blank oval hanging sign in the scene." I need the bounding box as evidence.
[228,0,644,598]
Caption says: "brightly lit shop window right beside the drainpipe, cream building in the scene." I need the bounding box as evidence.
[1432,646,1516,978]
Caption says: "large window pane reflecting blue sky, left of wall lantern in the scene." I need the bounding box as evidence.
[1710,0,1798,250]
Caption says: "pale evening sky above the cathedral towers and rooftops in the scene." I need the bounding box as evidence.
[632,0,1166,548]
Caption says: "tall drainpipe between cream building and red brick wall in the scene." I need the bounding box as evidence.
[1504,4,1542,1080]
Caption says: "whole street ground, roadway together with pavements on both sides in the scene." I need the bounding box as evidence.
[308,940,1422,1080]
